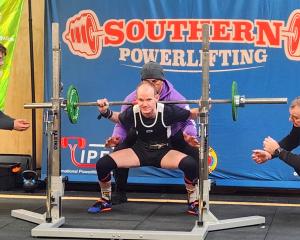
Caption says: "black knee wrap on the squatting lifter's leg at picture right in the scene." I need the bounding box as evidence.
[178,156,198,184]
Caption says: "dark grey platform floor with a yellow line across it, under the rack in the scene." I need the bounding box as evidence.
[0,188,300,240]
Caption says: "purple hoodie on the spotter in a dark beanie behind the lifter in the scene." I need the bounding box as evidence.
[112,80,197,141]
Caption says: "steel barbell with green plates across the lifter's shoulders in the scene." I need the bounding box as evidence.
[24,81,288,124]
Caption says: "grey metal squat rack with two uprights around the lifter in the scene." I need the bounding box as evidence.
[11,23,265,240]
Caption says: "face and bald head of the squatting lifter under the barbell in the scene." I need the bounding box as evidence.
[137,85,158,117]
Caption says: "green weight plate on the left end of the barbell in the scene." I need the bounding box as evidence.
[67,85,79,124]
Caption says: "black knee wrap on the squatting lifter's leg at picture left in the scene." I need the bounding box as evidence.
[96,155,117,182]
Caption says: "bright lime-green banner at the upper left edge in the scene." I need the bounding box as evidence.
[0,0,23,110]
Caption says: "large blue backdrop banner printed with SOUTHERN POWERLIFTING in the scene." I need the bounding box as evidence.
[43,0,300,188]
